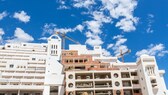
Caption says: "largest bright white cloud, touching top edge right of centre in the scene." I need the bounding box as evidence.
[102,0,138,32]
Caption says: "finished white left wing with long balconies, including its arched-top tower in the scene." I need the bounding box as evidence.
[0,35,64,95]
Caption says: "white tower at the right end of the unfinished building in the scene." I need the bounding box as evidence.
[137,55,168,95]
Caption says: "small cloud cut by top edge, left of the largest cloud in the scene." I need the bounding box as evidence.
[73,0,95,8]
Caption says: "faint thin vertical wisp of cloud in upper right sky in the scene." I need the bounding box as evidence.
[146,14,154,33]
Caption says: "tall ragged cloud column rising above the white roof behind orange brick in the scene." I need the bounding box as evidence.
[84,11,111,46]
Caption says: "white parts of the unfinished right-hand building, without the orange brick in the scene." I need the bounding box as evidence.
[66,45,168,95]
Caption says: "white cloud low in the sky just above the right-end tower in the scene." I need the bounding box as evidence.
[136,43,168,56]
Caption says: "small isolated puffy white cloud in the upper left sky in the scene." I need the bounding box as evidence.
[13,11,30,23]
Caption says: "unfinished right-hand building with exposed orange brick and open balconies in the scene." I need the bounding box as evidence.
[62,45,168,95]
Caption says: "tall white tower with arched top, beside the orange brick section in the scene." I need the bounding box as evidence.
[43,35,64,95]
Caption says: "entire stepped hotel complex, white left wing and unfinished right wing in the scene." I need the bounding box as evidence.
[0,35,168,95]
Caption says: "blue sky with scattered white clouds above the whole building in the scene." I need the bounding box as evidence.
[0,0,168,87]
